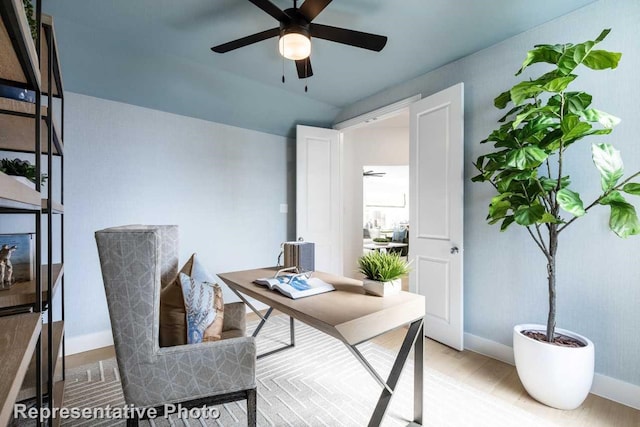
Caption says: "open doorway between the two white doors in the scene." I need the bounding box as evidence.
[342,109,409,279]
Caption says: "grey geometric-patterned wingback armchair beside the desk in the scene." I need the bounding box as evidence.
[95,225,256,426]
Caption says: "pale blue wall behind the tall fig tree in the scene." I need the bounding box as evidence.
[336,0,640,385]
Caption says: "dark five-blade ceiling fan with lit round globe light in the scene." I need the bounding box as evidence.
[211,0,387,82]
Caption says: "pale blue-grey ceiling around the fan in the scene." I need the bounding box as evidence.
[43,0,594,135]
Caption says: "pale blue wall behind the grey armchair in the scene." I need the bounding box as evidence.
[64,93,295,345]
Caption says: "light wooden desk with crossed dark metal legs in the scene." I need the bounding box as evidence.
[218,268,425,426]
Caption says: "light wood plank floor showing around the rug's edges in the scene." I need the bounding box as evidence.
[66,314,640,427]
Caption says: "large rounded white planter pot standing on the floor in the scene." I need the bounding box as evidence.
[513,324,594,409]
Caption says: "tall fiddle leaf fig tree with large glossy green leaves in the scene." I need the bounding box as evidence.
[472,30,640,342]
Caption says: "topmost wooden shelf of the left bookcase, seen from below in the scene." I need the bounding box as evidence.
[0,0,41,90]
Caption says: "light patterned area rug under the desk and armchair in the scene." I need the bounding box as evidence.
[51,316,554,427]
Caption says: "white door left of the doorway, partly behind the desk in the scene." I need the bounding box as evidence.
[296,125,342,274]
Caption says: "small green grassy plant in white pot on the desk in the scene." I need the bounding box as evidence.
[358,251,409,297]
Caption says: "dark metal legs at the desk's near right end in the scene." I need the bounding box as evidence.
[369,319,423,427]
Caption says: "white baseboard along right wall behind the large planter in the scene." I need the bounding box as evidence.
[464,333,640,410]
